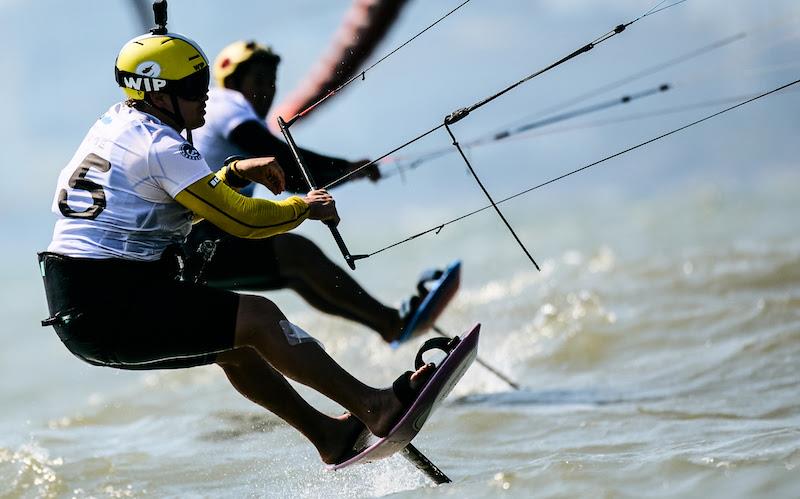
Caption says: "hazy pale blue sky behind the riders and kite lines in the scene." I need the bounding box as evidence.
[0,0,800,250]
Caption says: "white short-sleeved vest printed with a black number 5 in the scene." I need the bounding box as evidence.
[47,103,210,261]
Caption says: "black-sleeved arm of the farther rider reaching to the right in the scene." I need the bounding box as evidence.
[228,120,368,193]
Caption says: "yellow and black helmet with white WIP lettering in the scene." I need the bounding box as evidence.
[114,33,210,100]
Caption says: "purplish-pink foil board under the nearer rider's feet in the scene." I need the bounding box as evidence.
[327,324,481,470]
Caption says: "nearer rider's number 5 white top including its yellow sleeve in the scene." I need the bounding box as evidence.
[48,103,308,261]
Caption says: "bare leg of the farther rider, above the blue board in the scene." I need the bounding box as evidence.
[274,234,402,341]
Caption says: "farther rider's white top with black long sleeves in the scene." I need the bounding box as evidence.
[192,87,350,194]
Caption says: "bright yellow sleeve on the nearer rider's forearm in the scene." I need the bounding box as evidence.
[175,173,309,239]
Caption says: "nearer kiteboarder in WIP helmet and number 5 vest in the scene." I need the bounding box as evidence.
[39,29,440,463]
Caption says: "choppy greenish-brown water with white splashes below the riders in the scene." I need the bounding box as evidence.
[0,175,800,498]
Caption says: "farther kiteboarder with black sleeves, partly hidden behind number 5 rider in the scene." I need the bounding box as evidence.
[186,40,456,342]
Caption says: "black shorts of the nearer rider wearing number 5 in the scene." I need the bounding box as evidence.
[39,253,239,369]
